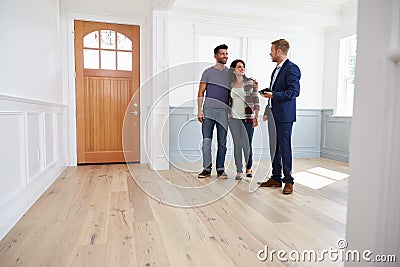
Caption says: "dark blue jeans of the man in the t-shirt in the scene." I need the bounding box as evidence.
[201,108,228,172]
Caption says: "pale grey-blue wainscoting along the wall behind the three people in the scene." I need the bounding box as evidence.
[169,107,340,162]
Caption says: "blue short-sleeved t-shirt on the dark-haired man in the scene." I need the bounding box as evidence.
[201,67,229,109]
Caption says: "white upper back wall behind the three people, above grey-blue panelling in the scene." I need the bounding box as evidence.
[168,12,325,108]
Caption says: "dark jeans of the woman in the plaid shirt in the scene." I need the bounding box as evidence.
[229,119,254,173]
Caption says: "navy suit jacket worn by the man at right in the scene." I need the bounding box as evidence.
[264,59,301,122]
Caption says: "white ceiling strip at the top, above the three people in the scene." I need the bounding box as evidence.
[167,0,357,27]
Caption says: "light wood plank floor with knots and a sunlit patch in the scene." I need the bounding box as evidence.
[0,158,348,267]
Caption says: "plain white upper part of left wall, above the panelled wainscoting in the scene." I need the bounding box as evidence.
[0,0,63,103]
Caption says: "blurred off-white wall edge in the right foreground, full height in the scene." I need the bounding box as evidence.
[346,0,400,266]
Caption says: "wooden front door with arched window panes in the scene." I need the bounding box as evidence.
[75,20,140,164]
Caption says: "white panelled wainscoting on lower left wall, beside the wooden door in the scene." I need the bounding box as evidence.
[0,94,67,240]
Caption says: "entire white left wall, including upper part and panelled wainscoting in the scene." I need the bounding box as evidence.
[0,0,67,239]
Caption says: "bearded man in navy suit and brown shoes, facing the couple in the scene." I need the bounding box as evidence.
[259,39,301,194]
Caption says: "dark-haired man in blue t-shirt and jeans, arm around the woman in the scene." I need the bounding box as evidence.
[197,44,229,179]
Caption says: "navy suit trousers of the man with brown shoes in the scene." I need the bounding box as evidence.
[271,121,294,184]
